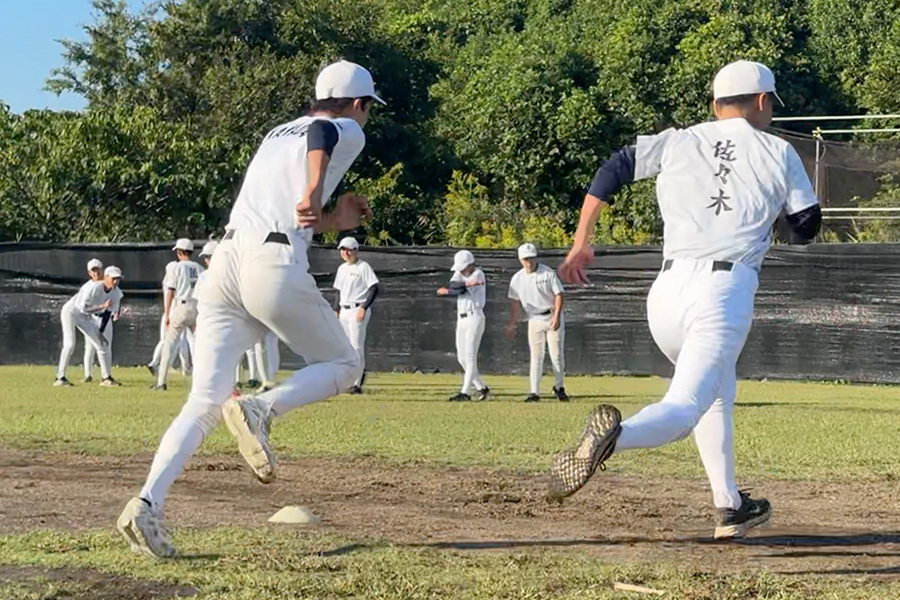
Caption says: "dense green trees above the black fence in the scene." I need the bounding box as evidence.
[0,0,900,246]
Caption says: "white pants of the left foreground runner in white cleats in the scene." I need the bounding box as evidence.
[141,231,359,511]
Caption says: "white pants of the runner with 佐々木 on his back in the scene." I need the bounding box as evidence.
[616,259,759,508]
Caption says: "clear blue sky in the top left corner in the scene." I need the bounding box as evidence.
[0,0,144,113]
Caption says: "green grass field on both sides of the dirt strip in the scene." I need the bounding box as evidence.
[0,367,900,600]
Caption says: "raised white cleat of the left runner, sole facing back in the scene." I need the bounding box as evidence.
[222,396,275,483]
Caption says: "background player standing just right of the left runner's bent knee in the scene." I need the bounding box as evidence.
[332,237,378,394]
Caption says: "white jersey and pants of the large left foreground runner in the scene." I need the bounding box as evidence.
[141,116,365,514]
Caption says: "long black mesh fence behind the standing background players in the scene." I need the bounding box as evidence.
[0,244,900,382]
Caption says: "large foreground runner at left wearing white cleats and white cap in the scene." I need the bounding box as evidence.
[117,61,381,556]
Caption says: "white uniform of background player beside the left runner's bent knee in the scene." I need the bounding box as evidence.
[332,260,378,386]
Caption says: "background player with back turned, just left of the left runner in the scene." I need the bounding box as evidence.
[152,238,203,390]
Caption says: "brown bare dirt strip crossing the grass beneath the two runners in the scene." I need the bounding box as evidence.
[0,448,900,578]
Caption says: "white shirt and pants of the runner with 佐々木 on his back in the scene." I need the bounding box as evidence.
[616,118,818,509]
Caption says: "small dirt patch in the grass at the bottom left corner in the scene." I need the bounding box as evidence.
[0,565,197,600]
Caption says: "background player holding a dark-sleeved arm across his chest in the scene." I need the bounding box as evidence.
[438,250,491,402]
